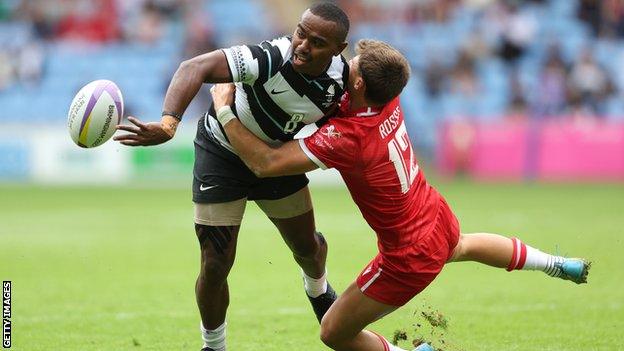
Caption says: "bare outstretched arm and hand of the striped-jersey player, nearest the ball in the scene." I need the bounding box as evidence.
[114,50,232,146]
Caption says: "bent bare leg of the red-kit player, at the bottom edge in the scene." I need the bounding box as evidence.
[321,283,403,351]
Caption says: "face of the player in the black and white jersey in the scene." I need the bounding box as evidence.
[292,10,347,76]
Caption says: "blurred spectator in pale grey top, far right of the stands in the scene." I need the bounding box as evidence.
[569,49,613,114]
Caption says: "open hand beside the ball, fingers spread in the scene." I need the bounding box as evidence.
[113,117,175,146]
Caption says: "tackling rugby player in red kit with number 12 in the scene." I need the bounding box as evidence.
[211,40,589,351]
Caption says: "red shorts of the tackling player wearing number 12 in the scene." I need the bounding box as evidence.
[356,198,459,306]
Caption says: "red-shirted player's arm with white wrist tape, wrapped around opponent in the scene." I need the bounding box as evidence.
[210,84,318,177]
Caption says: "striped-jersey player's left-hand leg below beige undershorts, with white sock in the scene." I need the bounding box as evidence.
[195,224,240,351]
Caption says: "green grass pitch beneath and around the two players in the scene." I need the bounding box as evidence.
[0,183,624,351]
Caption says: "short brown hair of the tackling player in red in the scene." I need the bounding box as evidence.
[355,39,410,105]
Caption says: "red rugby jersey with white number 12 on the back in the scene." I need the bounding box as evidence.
[299,94,440,253]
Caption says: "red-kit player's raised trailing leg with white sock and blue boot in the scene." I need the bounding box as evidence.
[449,233,590,284]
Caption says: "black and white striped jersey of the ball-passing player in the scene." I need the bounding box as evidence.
[203,37,349,152]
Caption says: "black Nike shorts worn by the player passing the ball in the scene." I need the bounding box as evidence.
[193,118,308,203]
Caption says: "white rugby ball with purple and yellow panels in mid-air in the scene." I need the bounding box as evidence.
[67,79,124,148]
